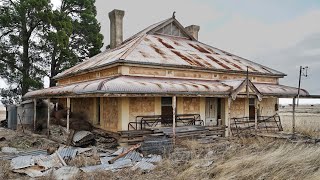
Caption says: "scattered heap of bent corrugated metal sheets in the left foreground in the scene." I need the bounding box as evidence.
[2,143,162,179]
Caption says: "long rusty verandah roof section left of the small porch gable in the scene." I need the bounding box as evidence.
[24,76,231,98]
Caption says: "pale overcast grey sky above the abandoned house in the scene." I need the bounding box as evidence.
[0,0,320,104]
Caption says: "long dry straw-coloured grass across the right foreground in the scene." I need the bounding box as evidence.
[77,138,320,180]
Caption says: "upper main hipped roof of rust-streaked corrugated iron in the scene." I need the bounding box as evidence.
[55,18,285,78]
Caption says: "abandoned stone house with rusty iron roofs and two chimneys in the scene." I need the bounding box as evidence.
[24,10,308,133]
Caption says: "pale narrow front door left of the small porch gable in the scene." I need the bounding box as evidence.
[205,98,218,126]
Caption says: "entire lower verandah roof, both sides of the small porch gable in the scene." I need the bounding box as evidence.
[24,76,308,98]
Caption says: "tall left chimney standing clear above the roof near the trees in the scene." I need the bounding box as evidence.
[109,9,124,49]
